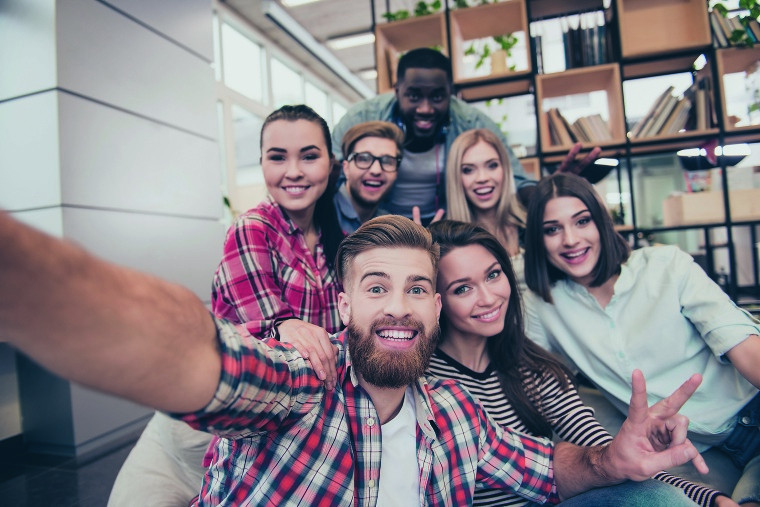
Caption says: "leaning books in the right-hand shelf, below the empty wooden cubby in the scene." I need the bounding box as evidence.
[629,77,712,139]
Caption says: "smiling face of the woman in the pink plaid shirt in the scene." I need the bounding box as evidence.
[261,120,332,229]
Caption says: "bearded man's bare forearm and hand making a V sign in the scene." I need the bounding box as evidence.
[554,370,707,498]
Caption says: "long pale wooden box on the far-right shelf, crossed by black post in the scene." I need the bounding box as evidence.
[662,188,760,227]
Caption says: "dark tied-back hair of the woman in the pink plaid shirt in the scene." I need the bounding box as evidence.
[259,104,344,268]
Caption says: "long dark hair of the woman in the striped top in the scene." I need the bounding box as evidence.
[428,220,572,438]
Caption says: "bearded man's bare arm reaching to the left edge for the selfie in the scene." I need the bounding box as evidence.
[0,211,221,412]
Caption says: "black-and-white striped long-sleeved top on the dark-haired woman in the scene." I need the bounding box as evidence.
[428,349,720,507]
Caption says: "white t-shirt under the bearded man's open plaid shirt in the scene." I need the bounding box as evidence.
[377,386,420,507]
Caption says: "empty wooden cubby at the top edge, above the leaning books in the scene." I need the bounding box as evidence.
[617,0,711,58]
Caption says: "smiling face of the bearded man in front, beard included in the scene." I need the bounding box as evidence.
[338,248,441,388]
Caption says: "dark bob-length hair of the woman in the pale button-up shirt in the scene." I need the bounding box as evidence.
[525,173,631,303]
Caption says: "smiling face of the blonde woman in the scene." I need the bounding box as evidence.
[461,139,504,217]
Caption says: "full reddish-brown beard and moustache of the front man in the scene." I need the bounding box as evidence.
[348,319,440,388]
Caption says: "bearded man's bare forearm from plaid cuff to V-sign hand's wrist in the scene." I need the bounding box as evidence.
[554,442,624,500]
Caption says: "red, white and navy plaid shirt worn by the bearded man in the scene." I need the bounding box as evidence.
[178,321,559,506]
